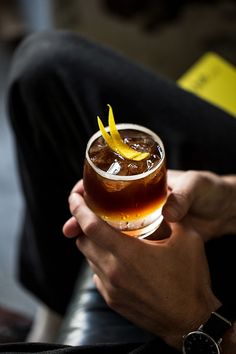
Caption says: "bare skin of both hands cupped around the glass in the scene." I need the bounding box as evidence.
[63,171,236,353]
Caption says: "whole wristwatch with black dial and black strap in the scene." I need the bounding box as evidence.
[182,306,232,354]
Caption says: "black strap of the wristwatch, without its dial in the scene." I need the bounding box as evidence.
[199,306,232,342]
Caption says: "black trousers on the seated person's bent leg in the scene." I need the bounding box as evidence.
[4,32,236,354]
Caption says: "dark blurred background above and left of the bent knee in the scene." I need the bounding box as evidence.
[0,0,236,342]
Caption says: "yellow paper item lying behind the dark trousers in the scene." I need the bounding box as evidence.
[177,52,236,118]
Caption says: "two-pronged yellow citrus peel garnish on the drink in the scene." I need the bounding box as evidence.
[97,104,150,161]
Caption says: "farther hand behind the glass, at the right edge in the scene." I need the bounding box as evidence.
[163,170,236,241]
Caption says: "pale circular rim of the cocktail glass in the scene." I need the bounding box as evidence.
[85,123,165,181]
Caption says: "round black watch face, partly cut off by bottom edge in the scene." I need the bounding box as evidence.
[183,331,220,354]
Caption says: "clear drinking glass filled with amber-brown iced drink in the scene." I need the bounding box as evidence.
[83,123,167,238]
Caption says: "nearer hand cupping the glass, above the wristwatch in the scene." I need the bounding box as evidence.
[63,182,220,349]
